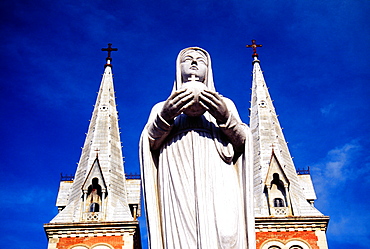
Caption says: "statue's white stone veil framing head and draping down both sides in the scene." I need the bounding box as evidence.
[139,47,256,249]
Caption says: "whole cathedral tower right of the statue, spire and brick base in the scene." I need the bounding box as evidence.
[247,40,329,249]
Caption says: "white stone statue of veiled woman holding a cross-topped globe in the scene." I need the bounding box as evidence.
[140,47,255,249]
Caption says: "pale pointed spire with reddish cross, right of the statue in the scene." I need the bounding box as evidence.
[247,45,321,216]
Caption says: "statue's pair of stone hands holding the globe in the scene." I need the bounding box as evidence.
[160,89,230,124]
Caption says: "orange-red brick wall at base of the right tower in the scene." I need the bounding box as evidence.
[256,231,319,249]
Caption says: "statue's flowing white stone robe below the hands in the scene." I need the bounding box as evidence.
[140,98,251,249]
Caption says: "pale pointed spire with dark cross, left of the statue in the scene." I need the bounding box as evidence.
[51,44,133,223]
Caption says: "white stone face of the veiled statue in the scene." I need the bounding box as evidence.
[180,50,208,82]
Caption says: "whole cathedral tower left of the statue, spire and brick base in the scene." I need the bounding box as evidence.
[44,44,141,249]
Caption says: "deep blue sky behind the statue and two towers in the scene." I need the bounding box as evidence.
[0,0,370,249]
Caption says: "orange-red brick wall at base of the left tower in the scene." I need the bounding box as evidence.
[57,236,124,249]
